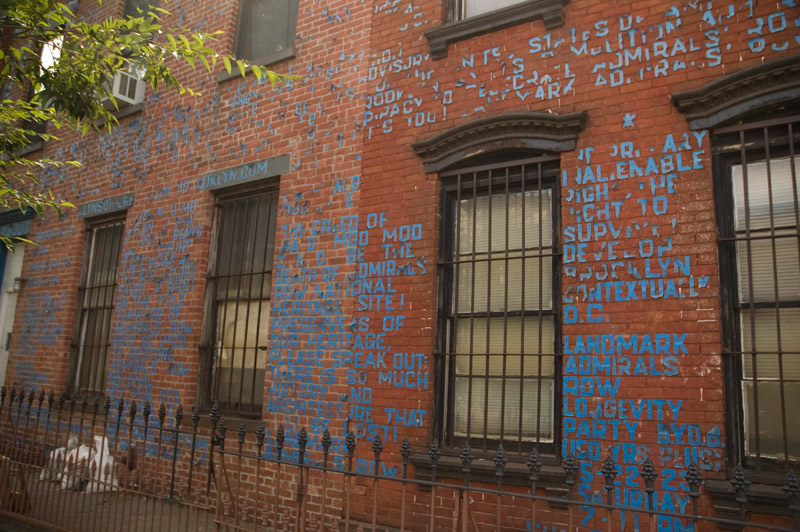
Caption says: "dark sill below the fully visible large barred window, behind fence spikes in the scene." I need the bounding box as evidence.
[410,453,568,508]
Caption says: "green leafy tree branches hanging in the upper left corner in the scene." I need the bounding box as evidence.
[0,0,295,246]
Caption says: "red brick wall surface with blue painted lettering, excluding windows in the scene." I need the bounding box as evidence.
[7,0,800,527]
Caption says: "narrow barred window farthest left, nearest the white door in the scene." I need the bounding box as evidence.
[73,220,125,393]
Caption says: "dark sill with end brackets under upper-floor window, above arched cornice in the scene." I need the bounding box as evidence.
[425,0,569,59]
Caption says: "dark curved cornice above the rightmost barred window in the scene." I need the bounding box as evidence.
[672,55,800,130]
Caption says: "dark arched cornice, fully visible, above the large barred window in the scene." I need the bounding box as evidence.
[411,112,588,173]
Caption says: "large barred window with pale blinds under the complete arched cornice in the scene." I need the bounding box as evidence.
[440,157,558,451]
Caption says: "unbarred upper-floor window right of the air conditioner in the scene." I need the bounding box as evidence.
[236,0,297,64]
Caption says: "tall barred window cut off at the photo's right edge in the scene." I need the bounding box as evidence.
[715,112,800,469]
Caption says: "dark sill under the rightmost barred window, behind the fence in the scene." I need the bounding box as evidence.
[705,479,792,530]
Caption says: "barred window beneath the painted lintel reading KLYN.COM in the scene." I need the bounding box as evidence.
[206,190,277,413]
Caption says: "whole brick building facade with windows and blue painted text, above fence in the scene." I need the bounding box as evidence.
[0,0,800,530]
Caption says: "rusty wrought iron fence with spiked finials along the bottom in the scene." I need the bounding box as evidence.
[0,388,800,532]
